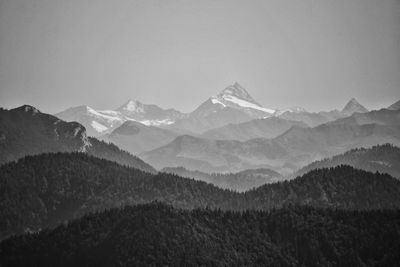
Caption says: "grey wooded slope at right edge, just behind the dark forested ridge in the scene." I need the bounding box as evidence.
[293,144,400,179]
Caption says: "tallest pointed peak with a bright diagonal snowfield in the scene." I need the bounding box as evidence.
[168,83,275,134]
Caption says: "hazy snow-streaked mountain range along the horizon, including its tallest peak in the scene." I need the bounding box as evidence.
[55,83,376,137]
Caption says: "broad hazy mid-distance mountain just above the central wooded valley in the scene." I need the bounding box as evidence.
[139,135,292,174]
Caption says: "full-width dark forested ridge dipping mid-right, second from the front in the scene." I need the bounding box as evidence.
[0,153,400,239]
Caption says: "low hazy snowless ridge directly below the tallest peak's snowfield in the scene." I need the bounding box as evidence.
[201,117,307,141]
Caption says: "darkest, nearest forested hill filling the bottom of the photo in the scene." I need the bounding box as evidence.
[0,203,400,267]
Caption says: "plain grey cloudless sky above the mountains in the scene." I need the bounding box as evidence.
[0,0,400,113]
